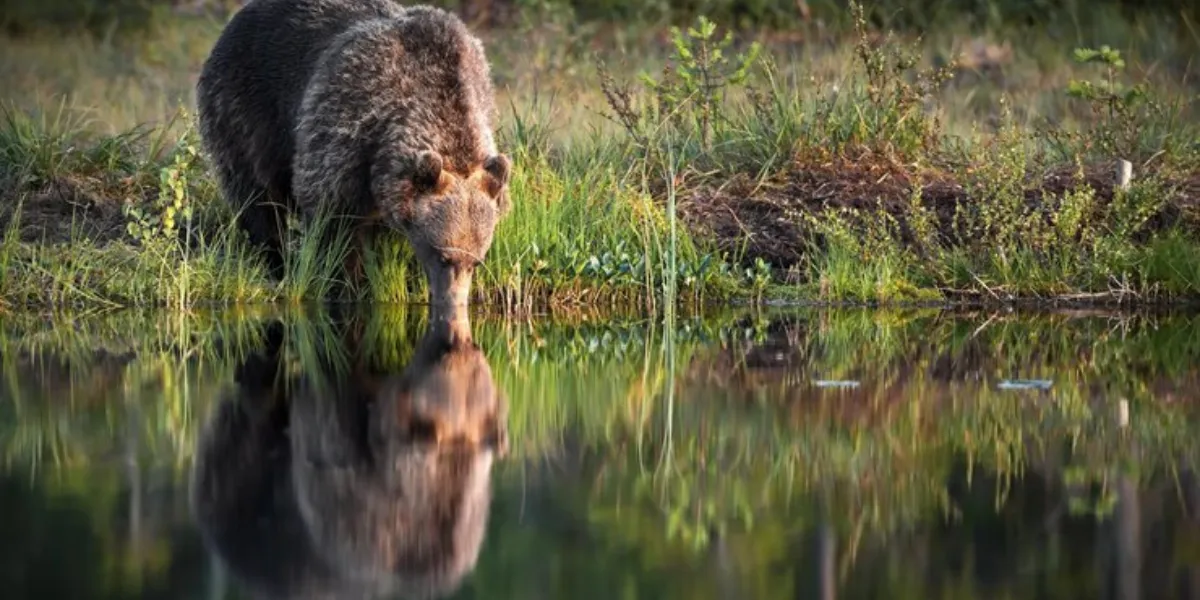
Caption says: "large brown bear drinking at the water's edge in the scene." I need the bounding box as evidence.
[197,0,511,305]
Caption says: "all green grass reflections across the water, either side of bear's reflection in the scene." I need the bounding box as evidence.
[0,307,1200,552]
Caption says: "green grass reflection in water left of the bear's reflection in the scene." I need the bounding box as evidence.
[0,311,267,469]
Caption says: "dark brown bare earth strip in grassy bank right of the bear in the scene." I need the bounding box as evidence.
[679,157,1200,269]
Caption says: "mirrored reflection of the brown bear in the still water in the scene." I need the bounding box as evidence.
[192,316,508,599]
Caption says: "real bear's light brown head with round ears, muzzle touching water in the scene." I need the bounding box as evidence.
[372,151,512,306]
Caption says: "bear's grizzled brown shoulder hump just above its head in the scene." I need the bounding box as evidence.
[295,6,497,180]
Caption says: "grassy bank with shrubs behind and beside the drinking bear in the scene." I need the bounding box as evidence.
[0,0,1200,311]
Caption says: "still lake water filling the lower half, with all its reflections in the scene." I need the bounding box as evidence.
[0,307,1200,599]
